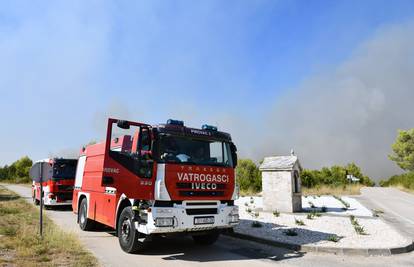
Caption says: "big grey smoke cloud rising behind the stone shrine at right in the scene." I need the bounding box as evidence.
[243,22,414,180]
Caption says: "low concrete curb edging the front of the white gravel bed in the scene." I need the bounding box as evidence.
[225,232,414,256]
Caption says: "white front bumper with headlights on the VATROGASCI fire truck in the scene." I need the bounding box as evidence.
[135,201,239,235]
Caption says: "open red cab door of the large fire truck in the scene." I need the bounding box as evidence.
[101,119,154,225]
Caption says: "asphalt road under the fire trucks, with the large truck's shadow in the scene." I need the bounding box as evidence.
[3,185,414,267]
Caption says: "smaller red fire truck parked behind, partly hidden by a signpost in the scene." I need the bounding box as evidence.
[32,158,77,207]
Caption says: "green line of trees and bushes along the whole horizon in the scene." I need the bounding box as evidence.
[0,129,414,192]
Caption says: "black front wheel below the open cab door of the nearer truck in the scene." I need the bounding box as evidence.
[117,207,145,253]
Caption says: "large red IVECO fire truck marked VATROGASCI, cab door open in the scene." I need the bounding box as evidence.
[72,119,239,253]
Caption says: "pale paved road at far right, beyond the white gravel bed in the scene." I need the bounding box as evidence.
[357,187,414,240]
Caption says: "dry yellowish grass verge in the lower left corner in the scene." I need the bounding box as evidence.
[0,186,97,266]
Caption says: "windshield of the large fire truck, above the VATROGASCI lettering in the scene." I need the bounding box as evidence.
[159,135,233,167]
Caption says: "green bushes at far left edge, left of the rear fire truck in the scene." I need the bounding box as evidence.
[0,156,33,183]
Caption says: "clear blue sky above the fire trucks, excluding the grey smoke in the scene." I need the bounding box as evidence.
[0,0,414,180]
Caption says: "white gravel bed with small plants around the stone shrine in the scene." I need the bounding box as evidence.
[235,197,409,248]
